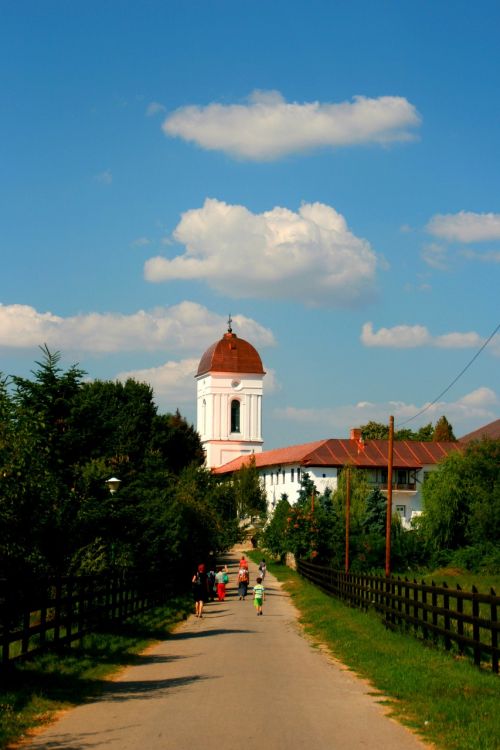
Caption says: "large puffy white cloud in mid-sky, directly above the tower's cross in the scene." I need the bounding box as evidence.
[144,199,377,307]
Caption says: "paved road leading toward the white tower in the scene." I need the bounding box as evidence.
[24,555,425,750]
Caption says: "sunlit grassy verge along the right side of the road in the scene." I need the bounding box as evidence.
[249,551,500,750]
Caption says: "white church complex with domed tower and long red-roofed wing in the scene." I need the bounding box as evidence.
[196,318,463,528]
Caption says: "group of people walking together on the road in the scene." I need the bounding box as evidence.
[191,555,267,617]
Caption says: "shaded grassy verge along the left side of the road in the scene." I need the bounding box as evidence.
[0,598,192,748]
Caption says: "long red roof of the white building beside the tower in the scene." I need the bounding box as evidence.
[213,439,463,474]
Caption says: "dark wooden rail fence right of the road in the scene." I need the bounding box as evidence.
[297,560,500,674]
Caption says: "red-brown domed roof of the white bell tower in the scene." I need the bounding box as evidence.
[196,331,265,376]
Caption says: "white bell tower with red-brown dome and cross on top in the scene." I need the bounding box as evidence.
[196,316,266,468]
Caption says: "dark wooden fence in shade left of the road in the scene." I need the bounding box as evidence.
[0,574,171,664]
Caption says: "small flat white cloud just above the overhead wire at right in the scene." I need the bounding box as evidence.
[361,322,494,354]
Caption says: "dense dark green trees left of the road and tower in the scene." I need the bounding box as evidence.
[0,346,240,579]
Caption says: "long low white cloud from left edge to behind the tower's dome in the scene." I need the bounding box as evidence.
[0,301,275,353]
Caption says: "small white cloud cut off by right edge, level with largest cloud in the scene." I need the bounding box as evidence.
[426,211,500,243]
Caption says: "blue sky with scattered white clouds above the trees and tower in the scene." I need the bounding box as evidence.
[0,0,500,448]
